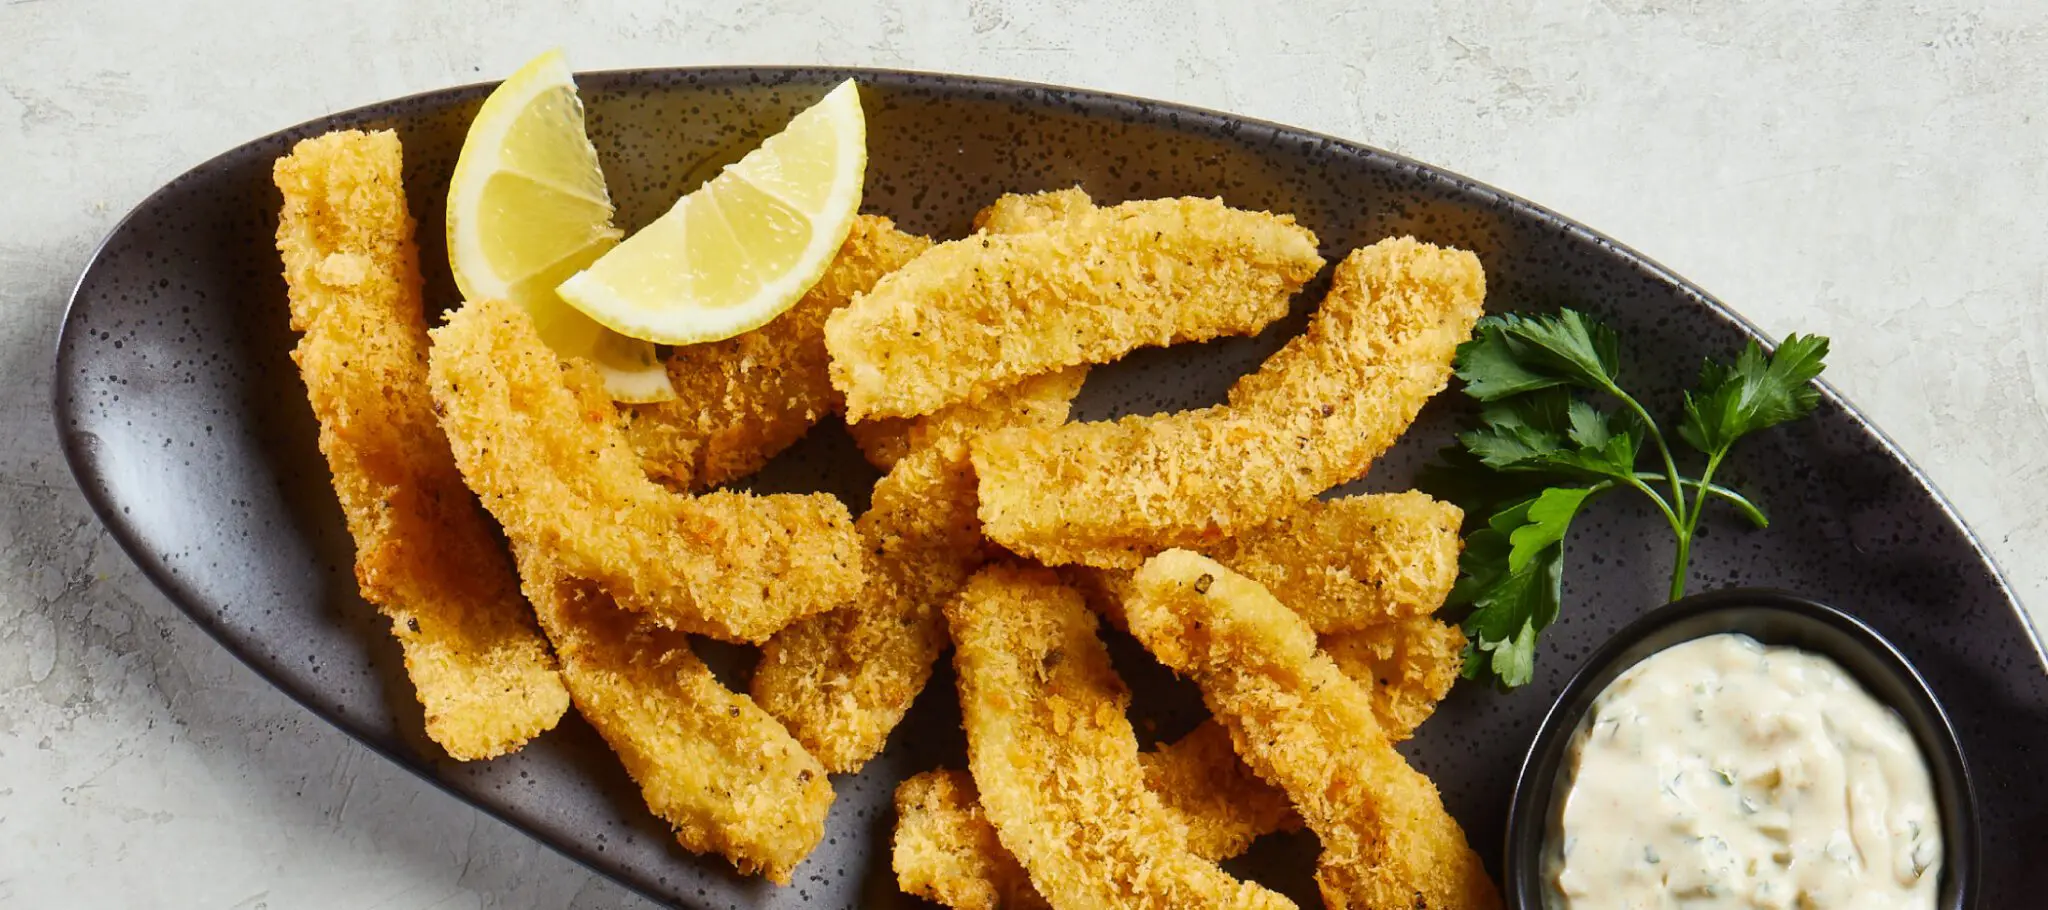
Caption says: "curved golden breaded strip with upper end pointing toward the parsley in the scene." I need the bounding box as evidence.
[975,238,1485,568]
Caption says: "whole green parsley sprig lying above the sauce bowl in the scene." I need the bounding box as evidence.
[1430,309,1827,687]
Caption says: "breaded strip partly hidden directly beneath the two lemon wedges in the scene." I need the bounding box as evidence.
[621,215,932,490]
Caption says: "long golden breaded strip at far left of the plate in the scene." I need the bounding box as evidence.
[272,131,569,760]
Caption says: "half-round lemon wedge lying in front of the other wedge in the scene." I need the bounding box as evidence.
[557,80,868,344]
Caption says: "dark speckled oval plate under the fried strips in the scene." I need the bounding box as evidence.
[55,70,2048,908]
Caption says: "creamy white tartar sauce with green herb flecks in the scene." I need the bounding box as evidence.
[1544,633,1942,910]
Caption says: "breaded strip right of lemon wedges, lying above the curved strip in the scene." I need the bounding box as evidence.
[825,199,1323,422]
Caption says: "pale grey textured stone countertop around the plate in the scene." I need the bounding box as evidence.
[0,0,2048,908]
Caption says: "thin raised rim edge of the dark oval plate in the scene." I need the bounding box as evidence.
[49,64,2048,904]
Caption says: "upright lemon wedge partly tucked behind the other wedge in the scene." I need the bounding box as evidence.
[449,51,676,402]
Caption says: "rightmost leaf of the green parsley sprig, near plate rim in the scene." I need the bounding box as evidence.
[1677,334,1827,455]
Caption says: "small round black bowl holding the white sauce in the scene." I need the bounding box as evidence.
[1505,588,1976,910]
